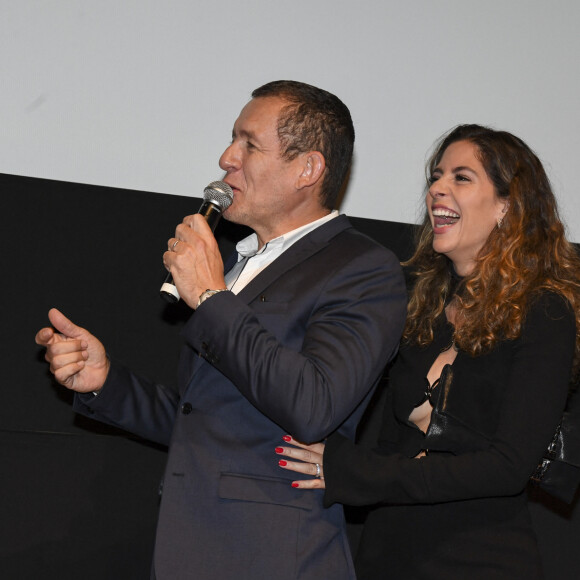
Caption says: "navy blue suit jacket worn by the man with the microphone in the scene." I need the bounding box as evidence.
[75,216,406,580]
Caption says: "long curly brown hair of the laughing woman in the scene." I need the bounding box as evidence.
[403,125,580,369]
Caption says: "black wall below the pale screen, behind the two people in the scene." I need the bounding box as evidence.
[0,174,580,580]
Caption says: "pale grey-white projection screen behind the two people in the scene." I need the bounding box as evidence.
[0,0,580,242]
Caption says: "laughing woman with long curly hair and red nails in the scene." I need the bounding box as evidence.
[276,125,580,580]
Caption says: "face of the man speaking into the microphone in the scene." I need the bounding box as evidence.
[219,97,300,242]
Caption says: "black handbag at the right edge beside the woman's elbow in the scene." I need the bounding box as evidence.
[530,388,580,503]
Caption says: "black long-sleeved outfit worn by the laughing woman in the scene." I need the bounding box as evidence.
[324,293,576,580]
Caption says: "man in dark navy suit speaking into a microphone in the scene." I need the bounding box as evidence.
[37,81,406,580]
